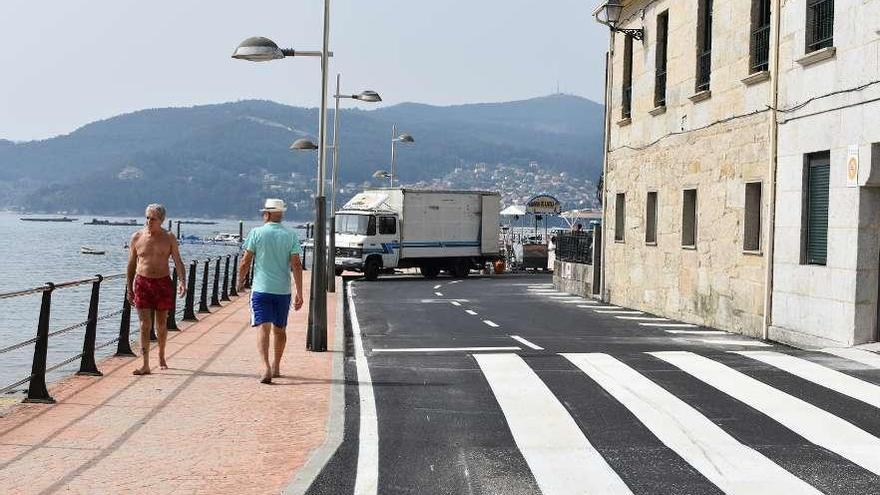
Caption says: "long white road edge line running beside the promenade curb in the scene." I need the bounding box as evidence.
[348,283,379,495]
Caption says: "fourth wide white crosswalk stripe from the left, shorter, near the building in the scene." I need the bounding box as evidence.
[735,351,880,408]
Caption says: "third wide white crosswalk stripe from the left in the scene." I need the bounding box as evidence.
[648,351,880,474]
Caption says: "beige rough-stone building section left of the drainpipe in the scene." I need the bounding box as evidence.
[603,0,772,336]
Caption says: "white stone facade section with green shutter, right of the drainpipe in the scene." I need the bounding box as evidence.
[769,0,880,346]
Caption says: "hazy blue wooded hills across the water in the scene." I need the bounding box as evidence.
[0,95,602,216]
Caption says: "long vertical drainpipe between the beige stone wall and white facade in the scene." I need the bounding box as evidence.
[761,0,782,340]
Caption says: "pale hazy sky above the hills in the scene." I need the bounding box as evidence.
[0,0,607,141]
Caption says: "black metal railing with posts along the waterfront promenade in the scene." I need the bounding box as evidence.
[0,254,239,404]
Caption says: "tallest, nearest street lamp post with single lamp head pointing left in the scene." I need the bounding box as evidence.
[232,0,331,351]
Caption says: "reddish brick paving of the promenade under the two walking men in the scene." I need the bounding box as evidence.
[0,277,342,494]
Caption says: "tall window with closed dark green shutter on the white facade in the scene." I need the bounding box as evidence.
[803,151,831,265]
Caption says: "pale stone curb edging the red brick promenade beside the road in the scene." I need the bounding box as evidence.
[281,277,347,495]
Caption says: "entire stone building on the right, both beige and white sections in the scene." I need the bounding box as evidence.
[597,0,880,345]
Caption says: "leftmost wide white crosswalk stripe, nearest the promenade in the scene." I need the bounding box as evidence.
[474,354,632,495]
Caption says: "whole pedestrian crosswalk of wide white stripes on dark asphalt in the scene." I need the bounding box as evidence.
[473,350,880,495]
